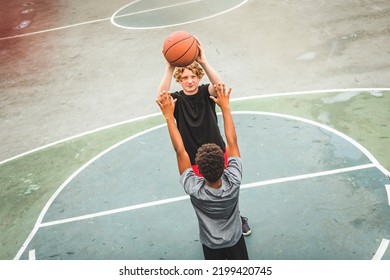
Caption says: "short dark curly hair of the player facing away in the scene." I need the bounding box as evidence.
[195,143,225,183]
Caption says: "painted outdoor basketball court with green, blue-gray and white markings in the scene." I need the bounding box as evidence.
[0,0,390,260]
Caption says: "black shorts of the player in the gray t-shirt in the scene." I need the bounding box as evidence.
[202,235,249,260]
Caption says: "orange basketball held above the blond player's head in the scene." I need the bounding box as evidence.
[163,31,199,67]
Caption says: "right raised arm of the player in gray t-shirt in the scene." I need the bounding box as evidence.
[210,83,240,157]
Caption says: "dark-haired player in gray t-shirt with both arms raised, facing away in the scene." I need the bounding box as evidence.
[156,83,249,260]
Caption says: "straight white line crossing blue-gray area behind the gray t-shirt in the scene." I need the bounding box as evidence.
[39,163,376,227]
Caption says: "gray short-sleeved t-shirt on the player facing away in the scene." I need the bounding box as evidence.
[180,157,242,249]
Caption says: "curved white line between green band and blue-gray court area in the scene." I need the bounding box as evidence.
[14,111,389,259]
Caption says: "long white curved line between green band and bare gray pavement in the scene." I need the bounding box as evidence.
[0,88,390,166]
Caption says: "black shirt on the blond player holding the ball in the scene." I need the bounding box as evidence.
[172,84,225,164]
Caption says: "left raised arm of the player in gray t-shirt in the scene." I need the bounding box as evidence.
[156,91,191,175]
